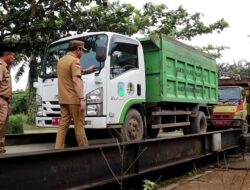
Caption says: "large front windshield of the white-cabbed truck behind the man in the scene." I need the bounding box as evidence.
[41,34,108,78]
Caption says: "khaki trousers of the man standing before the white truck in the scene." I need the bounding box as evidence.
[55,104,89,149]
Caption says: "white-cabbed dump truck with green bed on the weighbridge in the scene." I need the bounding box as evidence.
[34,32,218,141]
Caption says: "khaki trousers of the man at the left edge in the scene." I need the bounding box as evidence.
[0,98,9,153]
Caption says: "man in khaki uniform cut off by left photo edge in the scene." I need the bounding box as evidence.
[0,47,16,154]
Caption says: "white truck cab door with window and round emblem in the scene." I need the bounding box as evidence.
[107,36,145,124]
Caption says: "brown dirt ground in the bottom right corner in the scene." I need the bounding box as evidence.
[160,155,250,190]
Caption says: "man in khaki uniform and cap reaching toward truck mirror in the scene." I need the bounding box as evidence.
[55,40,95,149]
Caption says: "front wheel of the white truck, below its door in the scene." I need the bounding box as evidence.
[119,109,144,142]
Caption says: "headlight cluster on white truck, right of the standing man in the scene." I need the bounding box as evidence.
[86,87,103,116]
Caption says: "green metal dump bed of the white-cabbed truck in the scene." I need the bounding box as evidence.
[140,34,218,104]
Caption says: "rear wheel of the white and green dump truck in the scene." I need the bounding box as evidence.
[191,111,207,133]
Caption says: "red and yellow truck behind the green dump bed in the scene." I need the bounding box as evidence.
[208,75,250,134]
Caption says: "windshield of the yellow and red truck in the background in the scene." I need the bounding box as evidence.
[219,87,241,102]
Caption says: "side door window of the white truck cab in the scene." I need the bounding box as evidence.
[110,43,139,79]
